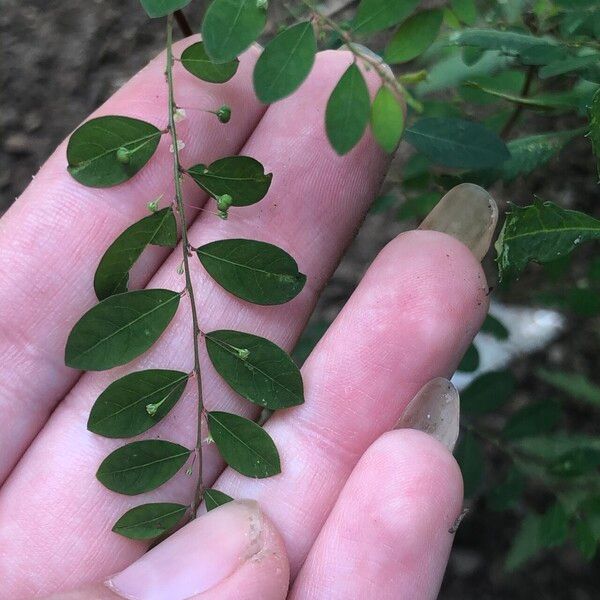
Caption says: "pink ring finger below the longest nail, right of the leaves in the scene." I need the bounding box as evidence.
[215,231,487,576]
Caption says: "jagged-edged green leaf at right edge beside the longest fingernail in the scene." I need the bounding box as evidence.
[496,200,600,278]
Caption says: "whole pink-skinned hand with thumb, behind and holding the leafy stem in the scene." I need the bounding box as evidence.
[0,40,494,600]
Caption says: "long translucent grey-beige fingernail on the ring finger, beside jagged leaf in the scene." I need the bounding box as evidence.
[419,183,498,260]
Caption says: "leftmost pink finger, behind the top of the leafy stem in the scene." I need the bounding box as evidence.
[0,40,264,483]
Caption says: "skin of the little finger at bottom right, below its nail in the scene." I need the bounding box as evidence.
[290,429,462,600]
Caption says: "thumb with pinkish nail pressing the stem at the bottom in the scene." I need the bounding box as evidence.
[48,501,289,600]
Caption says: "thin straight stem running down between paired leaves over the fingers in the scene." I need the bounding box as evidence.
[166,14,204,519]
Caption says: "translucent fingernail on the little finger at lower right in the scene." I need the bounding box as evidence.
[396,377,460,452]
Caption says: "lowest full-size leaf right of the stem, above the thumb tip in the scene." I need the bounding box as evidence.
[208,411,281,479]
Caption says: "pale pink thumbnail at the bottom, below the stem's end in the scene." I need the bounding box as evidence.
[105,501,265,600]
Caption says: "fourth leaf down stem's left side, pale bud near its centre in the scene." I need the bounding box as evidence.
[87,369,189,438]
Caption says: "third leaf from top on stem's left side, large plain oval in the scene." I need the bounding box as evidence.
[65,289,180,371]
